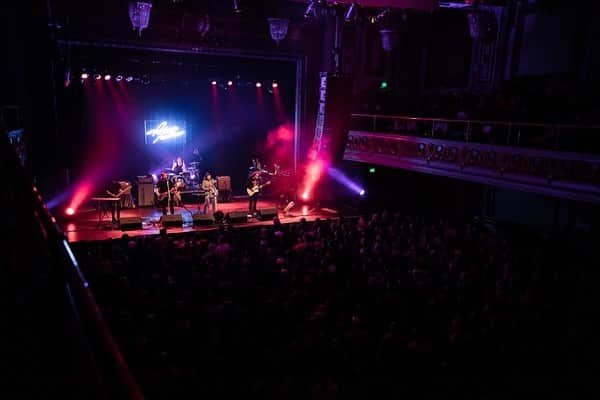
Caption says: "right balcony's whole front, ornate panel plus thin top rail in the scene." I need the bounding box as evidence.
[344,114,600,203]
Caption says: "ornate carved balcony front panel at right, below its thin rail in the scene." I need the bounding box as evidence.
[344,130,600,203]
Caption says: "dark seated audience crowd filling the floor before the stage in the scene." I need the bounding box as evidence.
[73,212,559,399]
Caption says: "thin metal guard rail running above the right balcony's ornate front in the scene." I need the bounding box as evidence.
[349,114,600,153]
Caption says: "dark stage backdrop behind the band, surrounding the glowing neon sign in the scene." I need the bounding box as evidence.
[64,79,294,193]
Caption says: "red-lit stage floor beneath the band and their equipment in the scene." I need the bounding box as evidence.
[59,197,339,242]
